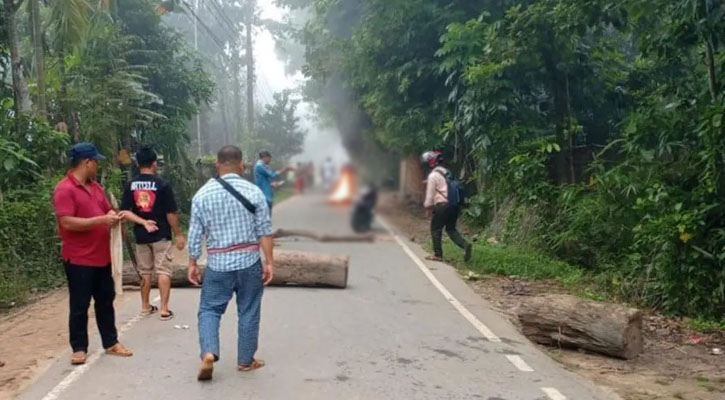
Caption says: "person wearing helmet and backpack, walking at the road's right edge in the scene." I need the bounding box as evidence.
[421,151,472,261]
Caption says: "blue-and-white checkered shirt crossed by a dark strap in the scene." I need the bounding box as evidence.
[189,174,272,272]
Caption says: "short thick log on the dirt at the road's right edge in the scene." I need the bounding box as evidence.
[516,295,644,359]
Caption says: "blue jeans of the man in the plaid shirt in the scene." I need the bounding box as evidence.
[199,261,264,365]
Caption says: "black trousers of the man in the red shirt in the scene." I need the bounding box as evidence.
[65,262,118,352]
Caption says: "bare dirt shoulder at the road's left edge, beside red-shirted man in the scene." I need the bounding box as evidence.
[0,288,138,400]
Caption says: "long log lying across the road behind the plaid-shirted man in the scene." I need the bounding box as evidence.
[123,250,350,288]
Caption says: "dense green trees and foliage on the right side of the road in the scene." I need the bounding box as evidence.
[288,0,725,317]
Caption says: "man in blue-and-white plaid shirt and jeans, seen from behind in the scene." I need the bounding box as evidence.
[188,146,274,380]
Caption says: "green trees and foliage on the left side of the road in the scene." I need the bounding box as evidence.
[0,0,213,306]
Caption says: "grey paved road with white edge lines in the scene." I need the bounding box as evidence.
[19,196,616,400]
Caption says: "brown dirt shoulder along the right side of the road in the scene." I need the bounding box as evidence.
[378,195,725,400]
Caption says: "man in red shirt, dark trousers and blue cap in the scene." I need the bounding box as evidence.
[53,143,133,365]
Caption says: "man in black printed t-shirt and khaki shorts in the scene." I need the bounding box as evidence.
[121,147,186,321]
